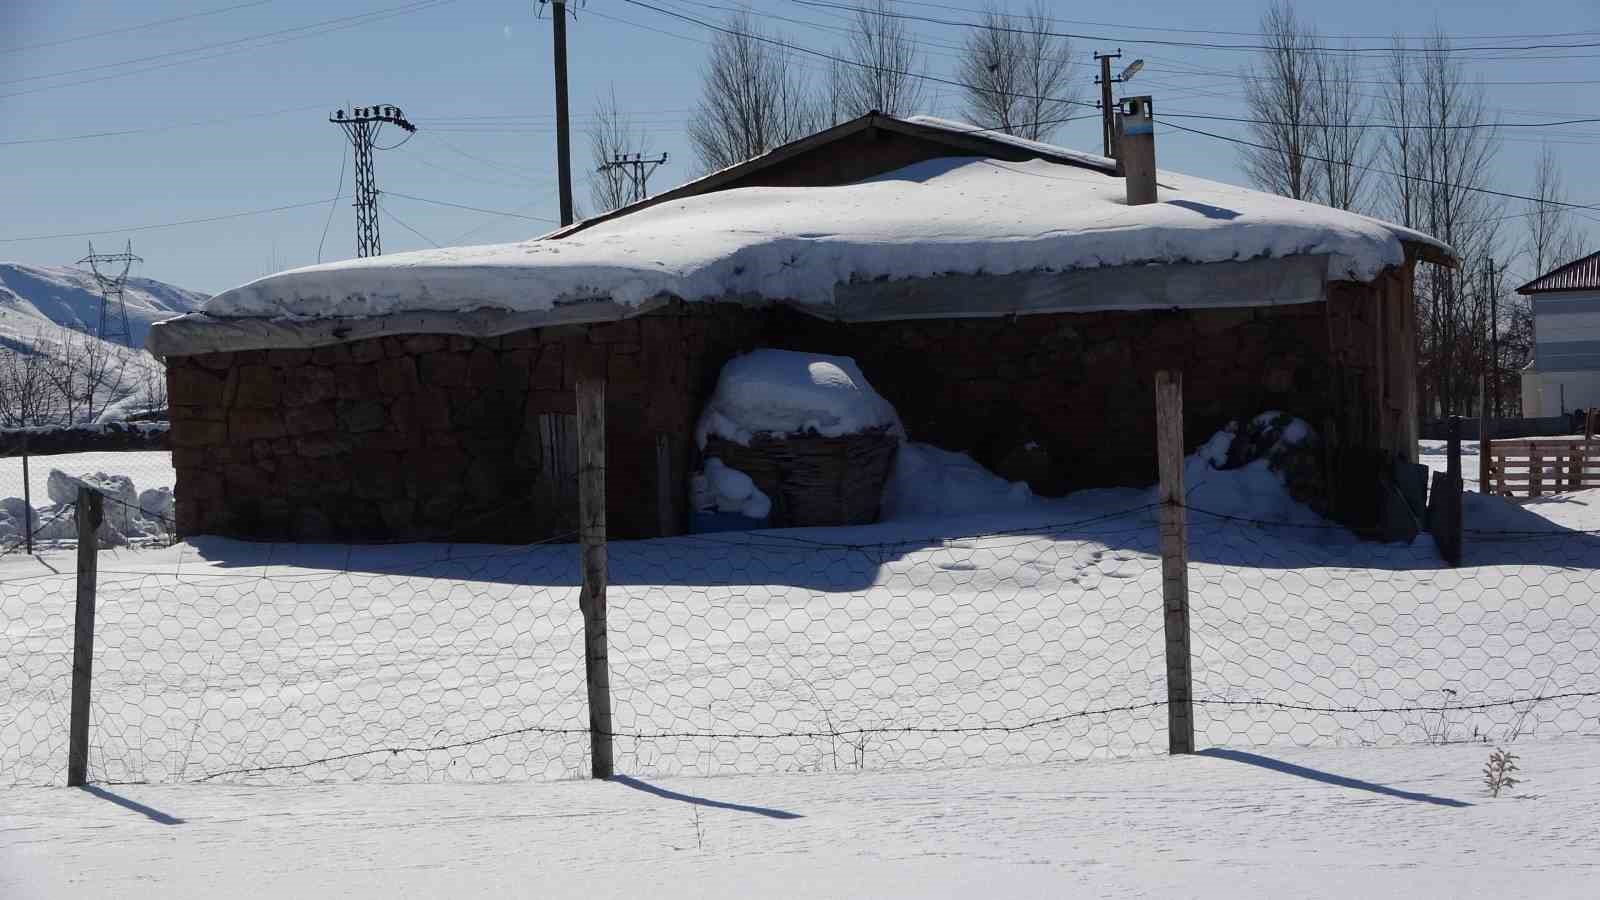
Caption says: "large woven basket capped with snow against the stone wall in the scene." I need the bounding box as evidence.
[694,349,904,527]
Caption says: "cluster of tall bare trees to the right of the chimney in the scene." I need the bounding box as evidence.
[1242,0,1584,415]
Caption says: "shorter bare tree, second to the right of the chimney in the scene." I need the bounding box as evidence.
[1310,53,1373,210]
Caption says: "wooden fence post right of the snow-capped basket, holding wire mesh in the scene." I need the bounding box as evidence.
[1155,370,1195,753]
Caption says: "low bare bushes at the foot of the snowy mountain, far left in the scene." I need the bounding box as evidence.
[0,331,166,428]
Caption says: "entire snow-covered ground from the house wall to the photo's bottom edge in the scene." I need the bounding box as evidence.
[0,435,1600,898]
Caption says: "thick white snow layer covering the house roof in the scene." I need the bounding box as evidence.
[190,157,1437,319]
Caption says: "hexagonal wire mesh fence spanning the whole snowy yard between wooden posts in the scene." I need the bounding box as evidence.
[0,493,1600,783]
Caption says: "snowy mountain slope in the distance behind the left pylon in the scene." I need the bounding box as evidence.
[0,263,208,348]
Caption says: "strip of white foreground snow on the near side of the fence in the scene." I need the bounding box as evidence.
[0,738,1600,900]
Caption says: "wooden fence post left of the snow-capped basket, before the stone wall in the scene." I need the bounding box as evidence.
[574,344,616,778]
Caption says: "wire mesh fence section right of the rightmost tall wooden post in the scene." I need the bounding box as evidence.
[1189,509,1600,746]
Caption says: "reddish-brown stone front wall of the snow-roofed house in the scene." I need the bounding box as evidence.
[170,288,1381,541]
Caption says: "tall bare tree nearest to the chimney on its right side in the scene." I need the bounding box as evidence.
[1242,0,1317,200]
